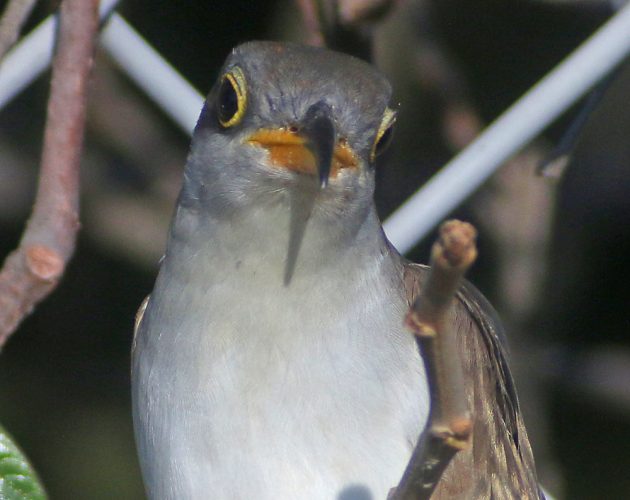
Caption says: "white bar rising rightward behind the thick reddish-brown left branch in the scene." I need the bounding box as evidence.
[0,0,120,109]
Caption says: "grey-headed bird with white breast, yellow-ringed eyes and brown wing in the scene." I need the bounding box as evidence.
[132,41,540,500]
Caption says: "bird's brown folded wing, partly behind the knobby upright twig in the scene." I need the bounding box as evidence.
[404,263,543,500]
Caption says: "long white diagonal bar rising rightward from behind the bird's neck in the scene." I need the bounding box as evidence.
[384,3,630,253]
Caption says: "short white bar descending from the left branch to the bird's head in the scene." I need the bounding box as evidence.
[101,13,204,134]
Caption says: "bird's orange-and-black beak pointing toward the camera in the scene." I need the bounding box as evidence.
[247,101,358,188]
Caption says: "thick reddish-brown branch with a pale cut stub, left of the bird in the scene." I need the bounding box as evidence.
[0,0,98,348]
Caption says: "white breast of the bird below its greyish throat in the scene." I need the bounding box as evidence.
[133,205,428,500]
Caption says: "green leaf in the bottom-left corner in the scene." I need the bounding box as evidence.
[0,426,46,500]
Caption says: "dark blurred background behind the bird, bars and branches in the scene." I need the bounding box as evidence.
[0,0,630,500]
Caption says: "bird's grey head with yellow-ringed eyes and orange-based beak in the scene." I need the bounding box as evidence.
[183,42,395,222]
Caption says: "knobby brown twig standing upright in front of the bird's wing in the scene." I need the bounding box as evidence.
[390,220,477,500]
